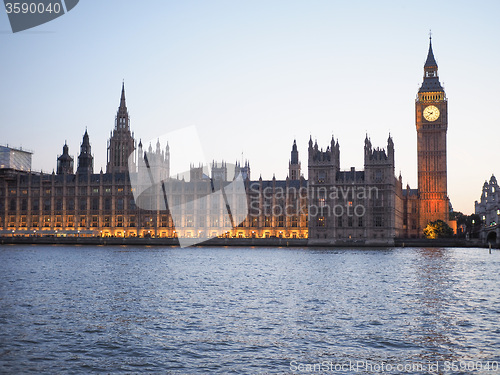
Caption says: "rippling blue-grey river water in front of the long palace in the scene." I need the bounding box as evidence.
[0,246,500,374]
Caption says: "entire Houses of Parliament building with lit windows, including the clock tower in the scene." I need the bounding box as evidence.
[0,40,449,244]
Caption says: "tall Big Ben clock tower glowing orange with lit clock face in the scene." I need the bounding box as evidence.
[415,38,449,232]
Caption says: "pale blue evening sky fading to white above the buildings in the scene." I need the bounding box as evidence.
[0,0,500,214]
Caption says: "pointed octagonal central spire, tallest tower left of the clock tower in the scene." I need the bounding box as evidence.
[106,84,135,173]
